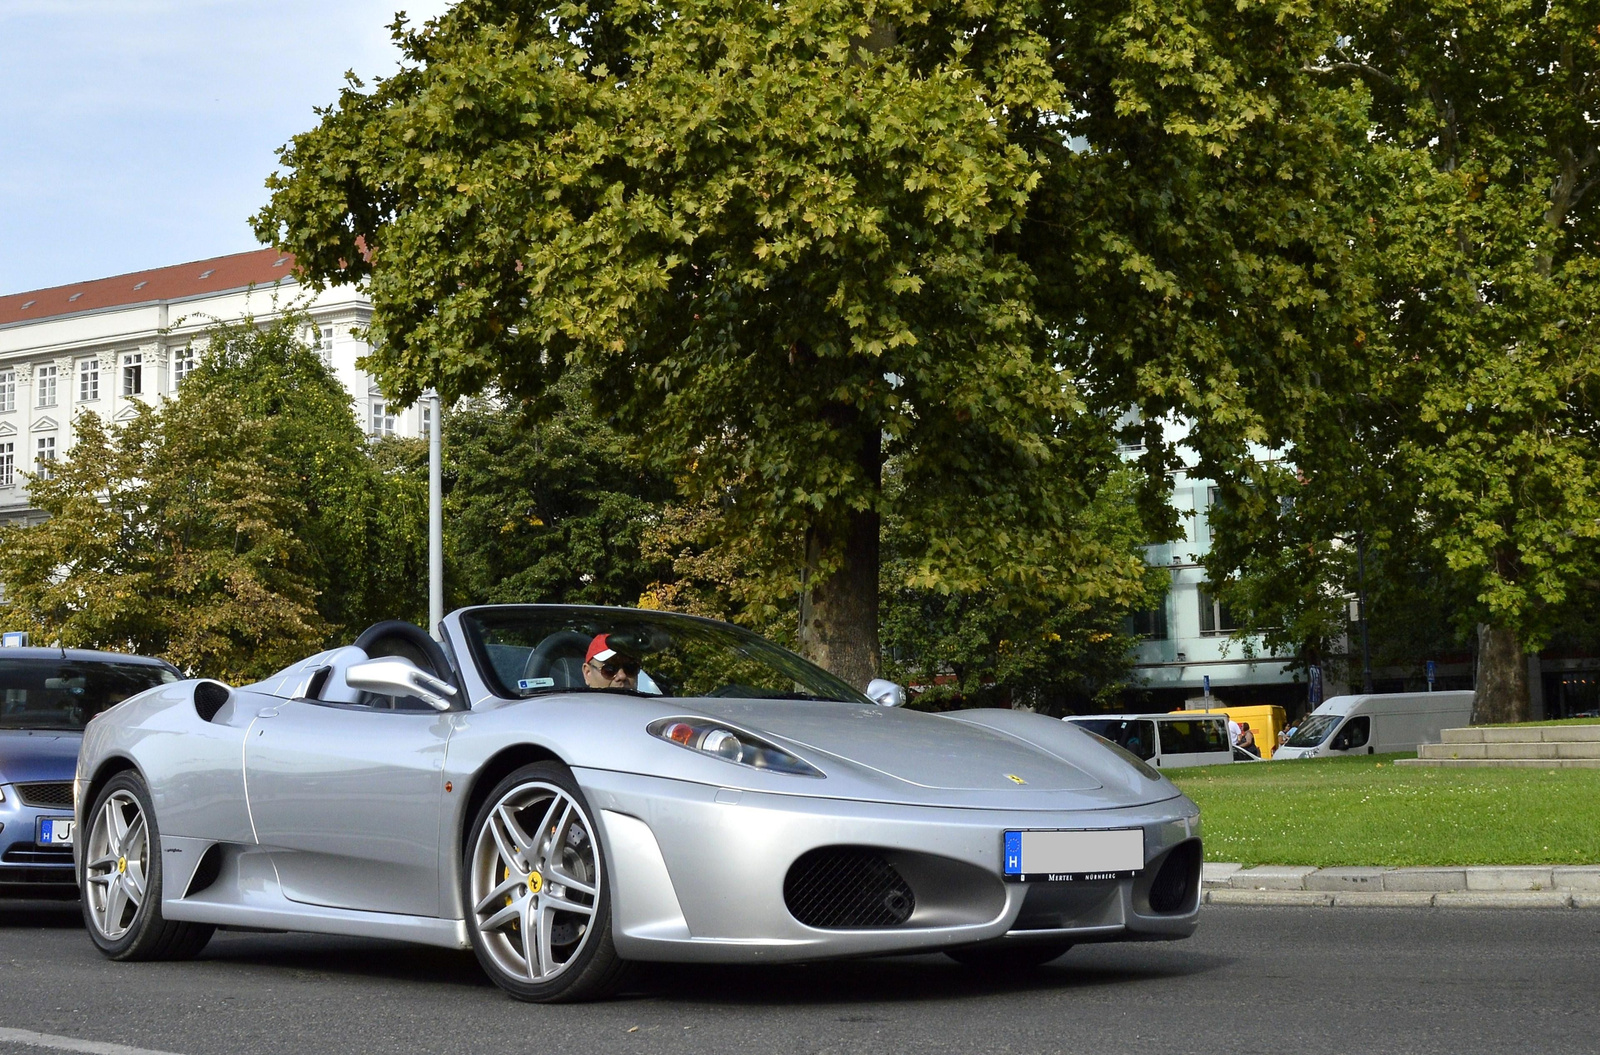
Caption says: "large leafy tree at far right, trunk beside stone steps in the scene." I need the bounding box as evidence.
[1214,0,1600,720]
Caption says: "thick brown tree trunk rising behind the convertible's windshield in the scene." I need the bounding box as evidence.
[800,512,878,688]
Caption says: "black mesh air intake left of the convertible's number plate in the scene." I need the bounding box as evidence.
[784,847,917,930]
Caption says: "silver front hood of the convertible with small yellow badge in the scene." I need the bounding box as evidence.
[681,700,1101,792]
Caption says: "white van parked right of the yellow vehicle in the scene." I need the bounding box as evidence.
[1272,692,1474,760]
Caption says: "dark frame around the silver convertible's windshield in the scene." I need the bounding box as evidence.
[454,605,878,708]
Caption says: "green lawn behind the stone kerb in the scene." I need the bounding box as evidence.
[1168,754,1600,868]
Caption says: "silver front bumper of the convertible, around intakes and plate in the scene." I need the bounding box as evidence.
[576,768,1200,962]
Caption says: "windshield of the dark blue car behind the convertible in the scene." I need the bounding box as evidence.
[0,658,178,730]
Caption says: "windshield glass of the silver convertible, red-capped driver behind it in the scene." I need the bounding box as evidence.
[461,605,872,706]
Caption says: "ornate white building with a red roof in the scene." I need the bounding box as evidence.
[0,250,427,520]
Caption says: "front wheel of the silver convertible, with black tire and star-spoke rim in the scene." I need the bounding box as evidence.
[461,762,630,1004]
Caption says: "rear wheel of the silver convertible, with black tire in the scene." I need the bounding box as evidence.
[78,770,216,961]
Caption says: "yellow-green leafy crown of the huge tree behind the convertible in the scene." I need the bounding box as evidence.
[256,0,1273,675]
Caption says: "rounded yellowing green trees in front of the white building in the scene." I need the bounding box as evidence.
[0,312,419,682]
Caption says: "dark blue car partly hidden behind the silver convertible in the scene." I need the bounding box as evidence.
[0,648,182,898]
